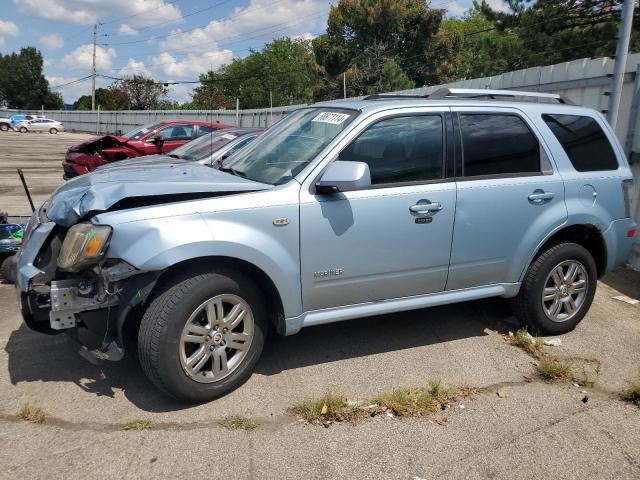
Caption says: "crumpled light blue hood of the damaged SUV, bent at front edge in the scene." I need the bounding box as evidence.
[43,162,272,227]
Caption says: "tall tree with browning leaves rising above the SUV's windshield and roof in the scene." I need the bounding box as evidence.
[313,0,462,94]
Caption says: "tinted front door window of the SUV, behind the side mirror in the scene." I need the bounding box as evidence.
[339,115,443,185]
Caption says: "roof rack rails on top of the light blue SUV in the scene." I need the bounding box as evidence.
[364,88,575,105]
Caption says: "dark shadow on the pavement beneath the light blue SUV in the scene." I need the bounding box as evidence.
[5,299,514,412]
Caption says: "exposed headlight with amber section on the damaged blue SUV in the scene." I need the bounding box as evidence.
[58,223,111,272]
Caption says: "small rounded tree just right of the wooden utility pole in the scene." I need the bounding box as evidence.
[108,75,168,110]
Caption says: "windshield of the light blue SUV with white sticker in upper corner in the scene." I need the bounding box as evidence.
[222,107,360,185]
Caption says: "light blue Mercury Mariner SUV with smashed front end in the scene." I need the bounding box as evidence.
[17,89,637,402]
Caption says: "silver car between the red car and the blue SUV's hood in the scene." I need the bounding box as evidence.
[98,128,263,169]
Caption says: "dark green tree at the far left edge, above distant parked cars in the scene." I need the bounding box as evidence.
[0,47,63,110]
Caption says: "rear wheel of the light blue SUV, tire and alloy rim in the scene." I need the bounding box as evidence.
[512,242,598,335]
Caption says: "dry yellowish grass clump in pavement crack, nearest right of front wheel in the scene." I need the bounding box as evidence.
[289,393,369,423]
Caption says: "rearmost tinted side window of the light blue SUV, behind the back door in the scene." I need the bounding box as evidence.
[542,114,618,172]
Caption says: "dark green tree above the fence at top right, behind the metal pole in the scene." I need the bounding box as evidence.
[474,0,640,70]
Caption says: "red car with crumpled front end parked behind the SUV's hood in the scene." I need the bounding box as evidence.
[62,120,232,180]
